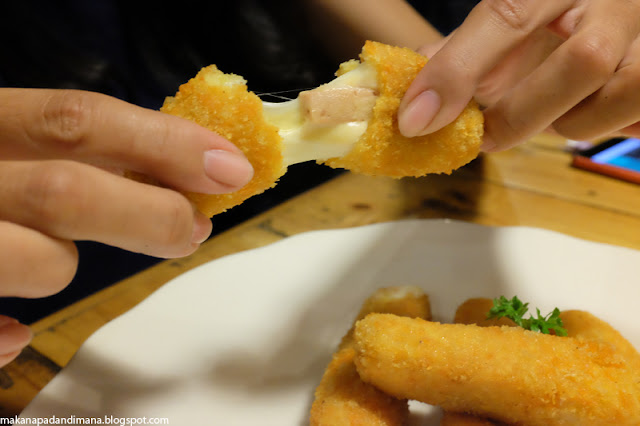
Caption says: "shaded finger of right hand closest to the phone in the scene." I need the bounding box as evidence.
[553,39,640,140]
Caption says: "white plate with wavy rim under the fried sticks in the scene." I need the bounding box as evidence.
[23,220,640,426]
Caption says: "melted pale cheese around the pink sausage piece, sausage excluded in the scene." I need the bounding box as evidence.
[263,64,377,166]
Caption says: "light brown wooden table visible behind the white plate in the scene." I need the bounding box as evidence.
[0,135,640,416]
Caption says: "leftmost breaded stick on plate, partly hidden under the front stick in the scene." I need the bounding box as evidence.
[310,286,431,426]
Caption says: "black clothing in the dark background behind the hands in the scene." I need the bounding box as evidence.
[0,0,475,323]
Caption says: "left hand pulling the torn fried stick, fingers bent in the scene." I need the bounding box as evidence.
[0,89,253,365]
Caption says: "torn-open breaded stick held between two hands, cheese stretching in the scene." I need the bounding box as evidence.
[161,42,483,216]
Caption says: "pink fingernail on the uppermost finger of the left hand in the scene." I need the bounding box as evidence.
[204,149,253,189]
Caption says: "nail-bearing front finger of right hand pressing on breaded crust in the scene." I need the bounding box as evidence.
[398,0,574,136]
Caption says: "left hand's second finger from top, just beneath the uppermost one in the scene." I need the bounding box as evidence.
[0,160,211,257]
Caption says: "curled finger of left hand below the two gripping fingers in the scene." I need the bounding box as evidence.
[0,221,78,297]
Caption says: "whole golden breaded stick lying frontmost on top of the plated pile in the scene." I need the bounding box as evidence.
[354,314,640,426]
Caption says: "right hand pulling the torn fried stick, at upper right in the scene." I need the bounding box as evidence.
[398,0,640,151]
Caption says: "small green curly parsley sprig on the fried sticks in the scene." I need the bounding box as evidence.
[487,296,567,336]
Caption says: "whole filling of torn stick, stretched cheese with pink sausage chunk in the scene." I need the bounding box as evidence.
[262,63,378,166]
